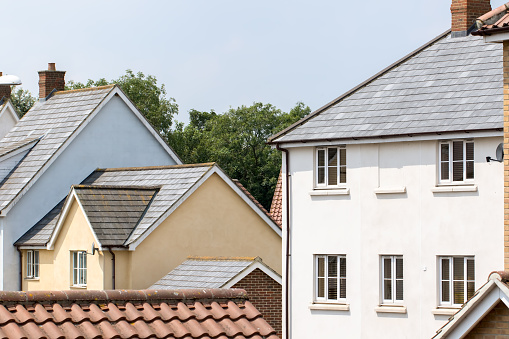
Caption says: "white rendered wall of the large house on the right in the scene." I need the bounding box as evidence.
[290,137,504,339]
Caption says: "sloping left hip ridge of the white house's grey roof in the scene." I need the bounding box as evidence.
[267,29,451,144]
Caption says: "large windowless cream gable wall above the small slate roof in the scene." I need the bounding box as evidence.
[131,174,281,289]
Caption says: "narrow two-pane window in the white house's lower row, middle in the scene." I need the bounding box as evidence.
[381,255,403,304]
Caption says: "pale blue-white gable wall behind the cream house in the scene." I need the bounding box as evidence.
[2,96,175,290]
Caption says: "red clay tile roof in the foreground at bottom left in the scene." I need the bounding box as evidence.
[0,289,278,339]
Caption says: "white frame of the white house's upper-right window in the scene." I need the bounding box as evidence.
[438,139,475,185]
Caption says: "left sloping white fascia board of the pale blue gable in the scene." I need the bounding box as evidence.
[0,87,115,215]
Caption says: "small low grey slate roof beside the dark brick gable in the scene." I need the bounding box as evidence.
[149,258,256,290]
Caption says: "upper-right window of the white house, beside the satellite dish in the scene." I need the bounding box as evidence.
[439,140,474,184]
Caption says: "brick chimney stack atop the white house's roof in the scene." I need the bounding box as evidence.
[451,0,491,38]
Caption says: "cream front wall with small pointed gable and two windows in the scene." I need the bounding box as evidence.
[23,201,105,290]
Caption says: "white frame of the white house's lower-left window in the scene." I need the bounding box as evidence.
[314,254,347,303]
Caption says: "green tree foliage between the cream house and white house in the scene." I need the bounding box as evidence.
[167,102,311,209]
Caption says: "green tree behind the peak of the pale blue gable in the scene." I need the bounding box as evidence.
[66,69,178,135]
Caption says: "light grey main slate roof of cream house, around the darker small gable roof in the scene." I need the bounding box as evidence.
[15,163,214,246]
